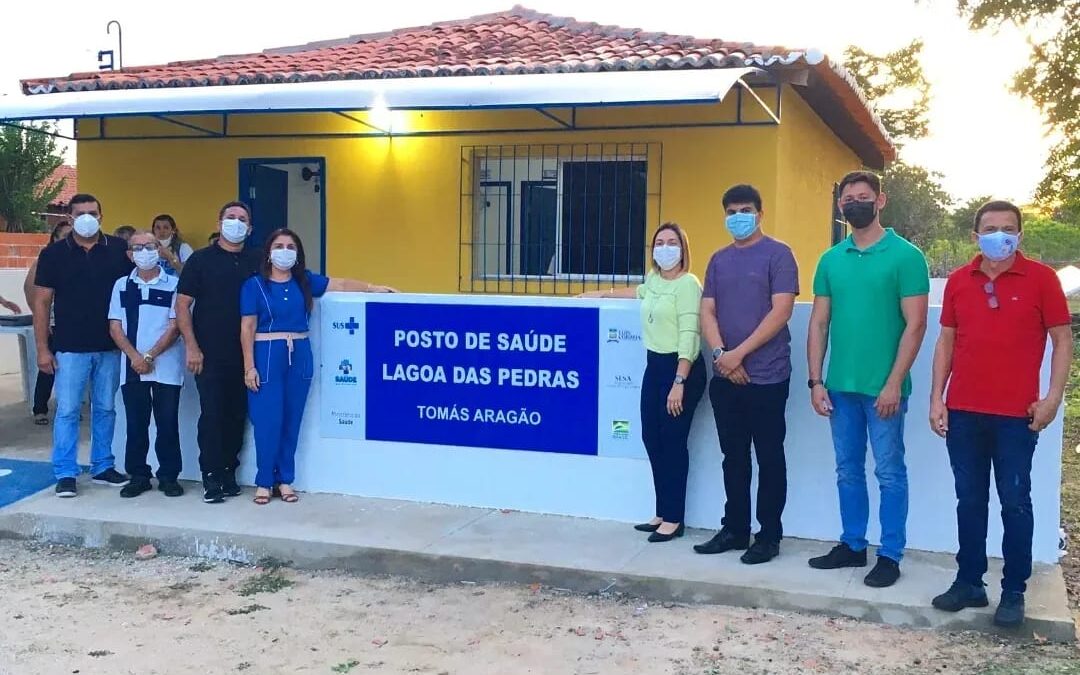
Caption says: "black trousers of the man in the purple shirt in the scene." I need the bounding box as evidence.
[708,376,791,542]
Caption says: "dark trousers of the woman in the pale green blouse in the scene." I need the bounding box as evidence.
[642,351,705,523]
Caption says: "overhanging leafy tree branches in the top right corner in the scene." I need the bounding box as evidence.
[956,0,1080,214]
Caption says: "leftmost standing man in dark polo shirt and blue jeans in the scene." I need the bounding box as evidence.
[33,194,133,497]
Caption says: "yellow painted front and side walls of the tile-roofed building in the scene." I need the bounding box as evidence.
[78,84,858,293]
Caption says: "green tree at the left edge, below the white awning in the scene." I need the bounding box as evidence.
[0,124,64,232]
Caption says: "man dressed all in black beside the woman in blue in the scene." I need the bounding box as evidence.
[176,202,259,503]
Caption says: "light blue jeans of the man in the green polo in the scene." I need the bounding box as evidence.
[828,391,907,563]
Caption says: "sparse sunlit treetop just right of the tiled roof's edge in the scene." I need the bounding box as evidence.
[843,40,930,145]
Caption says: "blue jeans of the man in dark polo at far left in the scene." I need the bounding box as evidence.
[53,351,120,481]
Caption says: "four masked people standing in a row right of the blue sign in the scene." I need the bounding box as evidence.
[584,171,1072,626]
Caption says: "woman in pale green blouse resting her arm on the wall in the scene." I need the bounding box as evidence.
[582,222,705,542]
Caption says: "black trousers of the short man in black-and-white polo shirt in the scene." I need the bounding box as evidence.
[120,381,181,483]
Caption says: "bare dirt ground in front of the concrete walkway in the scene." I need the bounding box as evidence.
[0,541,1080,675]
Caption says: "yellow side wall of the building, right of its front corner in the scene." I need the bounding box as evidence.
[766,87,862,291]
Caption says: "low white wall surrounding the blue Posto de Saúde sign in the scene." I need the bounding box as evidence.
[114,294,1063,563]
